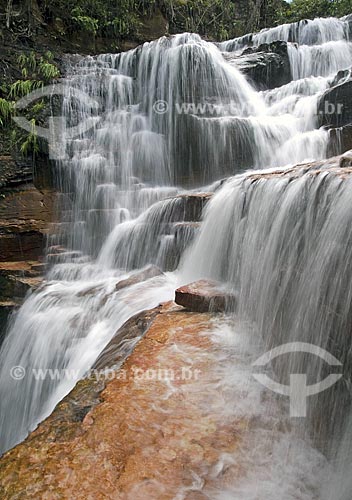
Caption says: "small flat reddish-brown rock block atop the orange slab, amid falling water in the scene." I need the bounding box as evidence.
[175,280,235,312]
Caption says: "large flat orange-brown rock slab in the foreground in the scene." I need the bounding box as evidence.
[0,306,246,500]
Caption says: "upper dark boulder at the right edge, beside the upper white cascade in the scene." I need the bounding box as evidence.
[318,80,352,127]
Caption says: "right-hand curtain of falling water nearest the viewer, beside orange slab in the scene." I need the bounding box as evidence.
[182,165,352,492]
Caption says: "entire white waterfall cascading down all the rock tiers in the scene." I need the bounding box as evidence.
[0,13,352,500]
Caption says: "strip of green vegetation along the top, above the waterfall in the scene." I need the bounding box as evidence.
[0,0,352,42]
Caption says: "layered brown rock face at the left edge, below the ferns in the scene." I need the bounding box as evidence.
[0,156,56,344]
